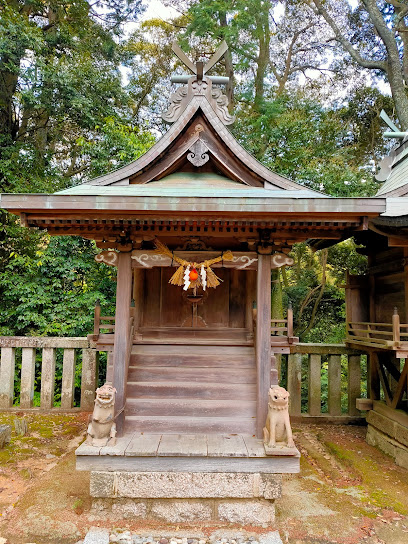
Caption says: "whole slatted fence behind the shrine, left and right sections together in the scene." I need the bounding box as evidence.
[0,337,366,423]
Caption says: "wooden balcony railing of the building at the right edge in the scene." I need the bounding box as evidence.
[346,308,408,349]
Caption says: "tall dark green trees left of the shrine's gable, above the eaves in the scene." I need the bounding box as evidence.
[0,0,151,192]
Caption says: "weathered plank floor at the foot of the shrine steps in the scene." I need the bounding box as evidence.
[75,432,300,473]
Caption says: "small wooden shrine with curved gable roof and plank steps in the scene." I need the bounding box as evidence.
[2,46,385,515]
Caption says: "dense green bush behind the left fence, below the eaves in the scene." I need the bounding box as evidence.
[0,236,115,336]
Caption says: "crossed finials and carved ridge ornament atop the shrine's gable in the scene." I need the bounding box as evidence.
[162,42,234,125]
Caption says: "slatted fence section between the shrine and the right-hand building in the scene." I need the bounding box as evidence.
[281,344,367,423]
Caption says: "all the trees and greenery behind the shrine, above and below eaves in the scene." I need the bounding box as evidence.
[0,0,408,340]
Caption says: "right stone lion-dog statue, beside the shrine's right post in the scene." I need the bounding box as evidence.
[263,385,295,455]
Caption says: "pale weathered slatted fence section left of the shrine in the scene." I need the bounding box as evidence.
[0,336,99,411]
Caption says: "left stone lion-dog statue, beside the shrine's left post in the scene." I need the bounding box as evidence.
[86,383,116,446]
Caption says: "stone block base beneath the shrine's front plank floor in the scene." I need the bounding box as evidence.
[91,471,282,525]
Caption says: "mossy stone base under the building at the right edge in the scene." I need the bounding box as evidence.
[366,401,408,469]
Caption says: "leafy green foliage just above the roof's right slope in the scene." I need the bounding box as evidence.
[233,92,384,196]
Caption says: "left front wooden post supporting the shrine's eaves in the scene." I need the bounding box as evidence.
[113,251,132,436]
